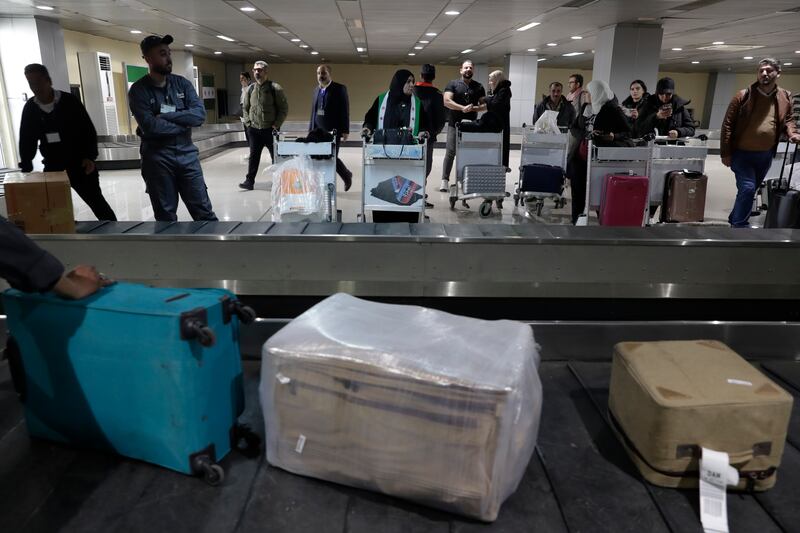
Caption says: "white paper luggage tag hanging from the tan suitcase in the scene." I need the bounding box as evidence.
[700,448,739,533]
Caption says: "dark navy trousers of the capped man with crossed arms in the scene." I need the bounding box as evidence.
[142,149,217,221]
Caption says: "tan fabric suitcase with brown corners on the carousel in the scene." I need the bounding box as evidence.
[608,340,793,490]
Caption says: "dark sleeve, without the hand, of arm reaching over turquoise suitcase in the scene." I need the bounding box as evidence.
[0,217,64,292]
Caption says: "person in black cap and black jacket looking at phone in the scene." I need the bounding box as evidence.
[634,78,694,139]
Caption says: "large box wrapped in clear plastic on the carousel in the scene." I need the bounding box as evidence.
[260,294,542,521]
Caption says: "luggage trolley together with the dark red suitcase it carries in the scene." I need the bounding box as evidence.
[576,141,653,226]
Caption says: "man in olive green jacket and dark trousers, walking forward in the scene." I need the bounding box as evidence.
[239,61,289,191]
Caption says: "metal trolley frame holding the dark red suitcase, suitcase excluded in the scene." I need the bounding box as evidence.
[575,141,653,226]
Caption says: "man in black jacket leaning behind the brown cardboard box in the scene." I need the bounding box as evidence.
[19,63,117,220]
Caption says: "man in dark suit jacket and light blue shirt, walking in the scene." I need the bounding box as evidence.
[308,65,353,191]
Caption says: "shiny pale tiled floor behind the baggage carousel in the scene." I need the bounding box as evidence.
[73,147,760,224]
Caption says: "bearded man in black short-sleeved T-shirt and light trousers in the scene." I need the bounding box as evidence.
[439,59,486,192]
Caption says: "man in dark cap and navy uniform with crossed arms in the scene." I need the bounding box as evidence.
[128,35,217,221]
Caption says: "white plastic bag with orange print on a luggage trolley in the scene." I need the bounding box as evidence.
[267,156,325,222]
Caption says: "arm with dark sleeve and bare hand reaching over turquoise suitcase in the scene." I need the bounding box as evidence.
[0,217,111,300]
